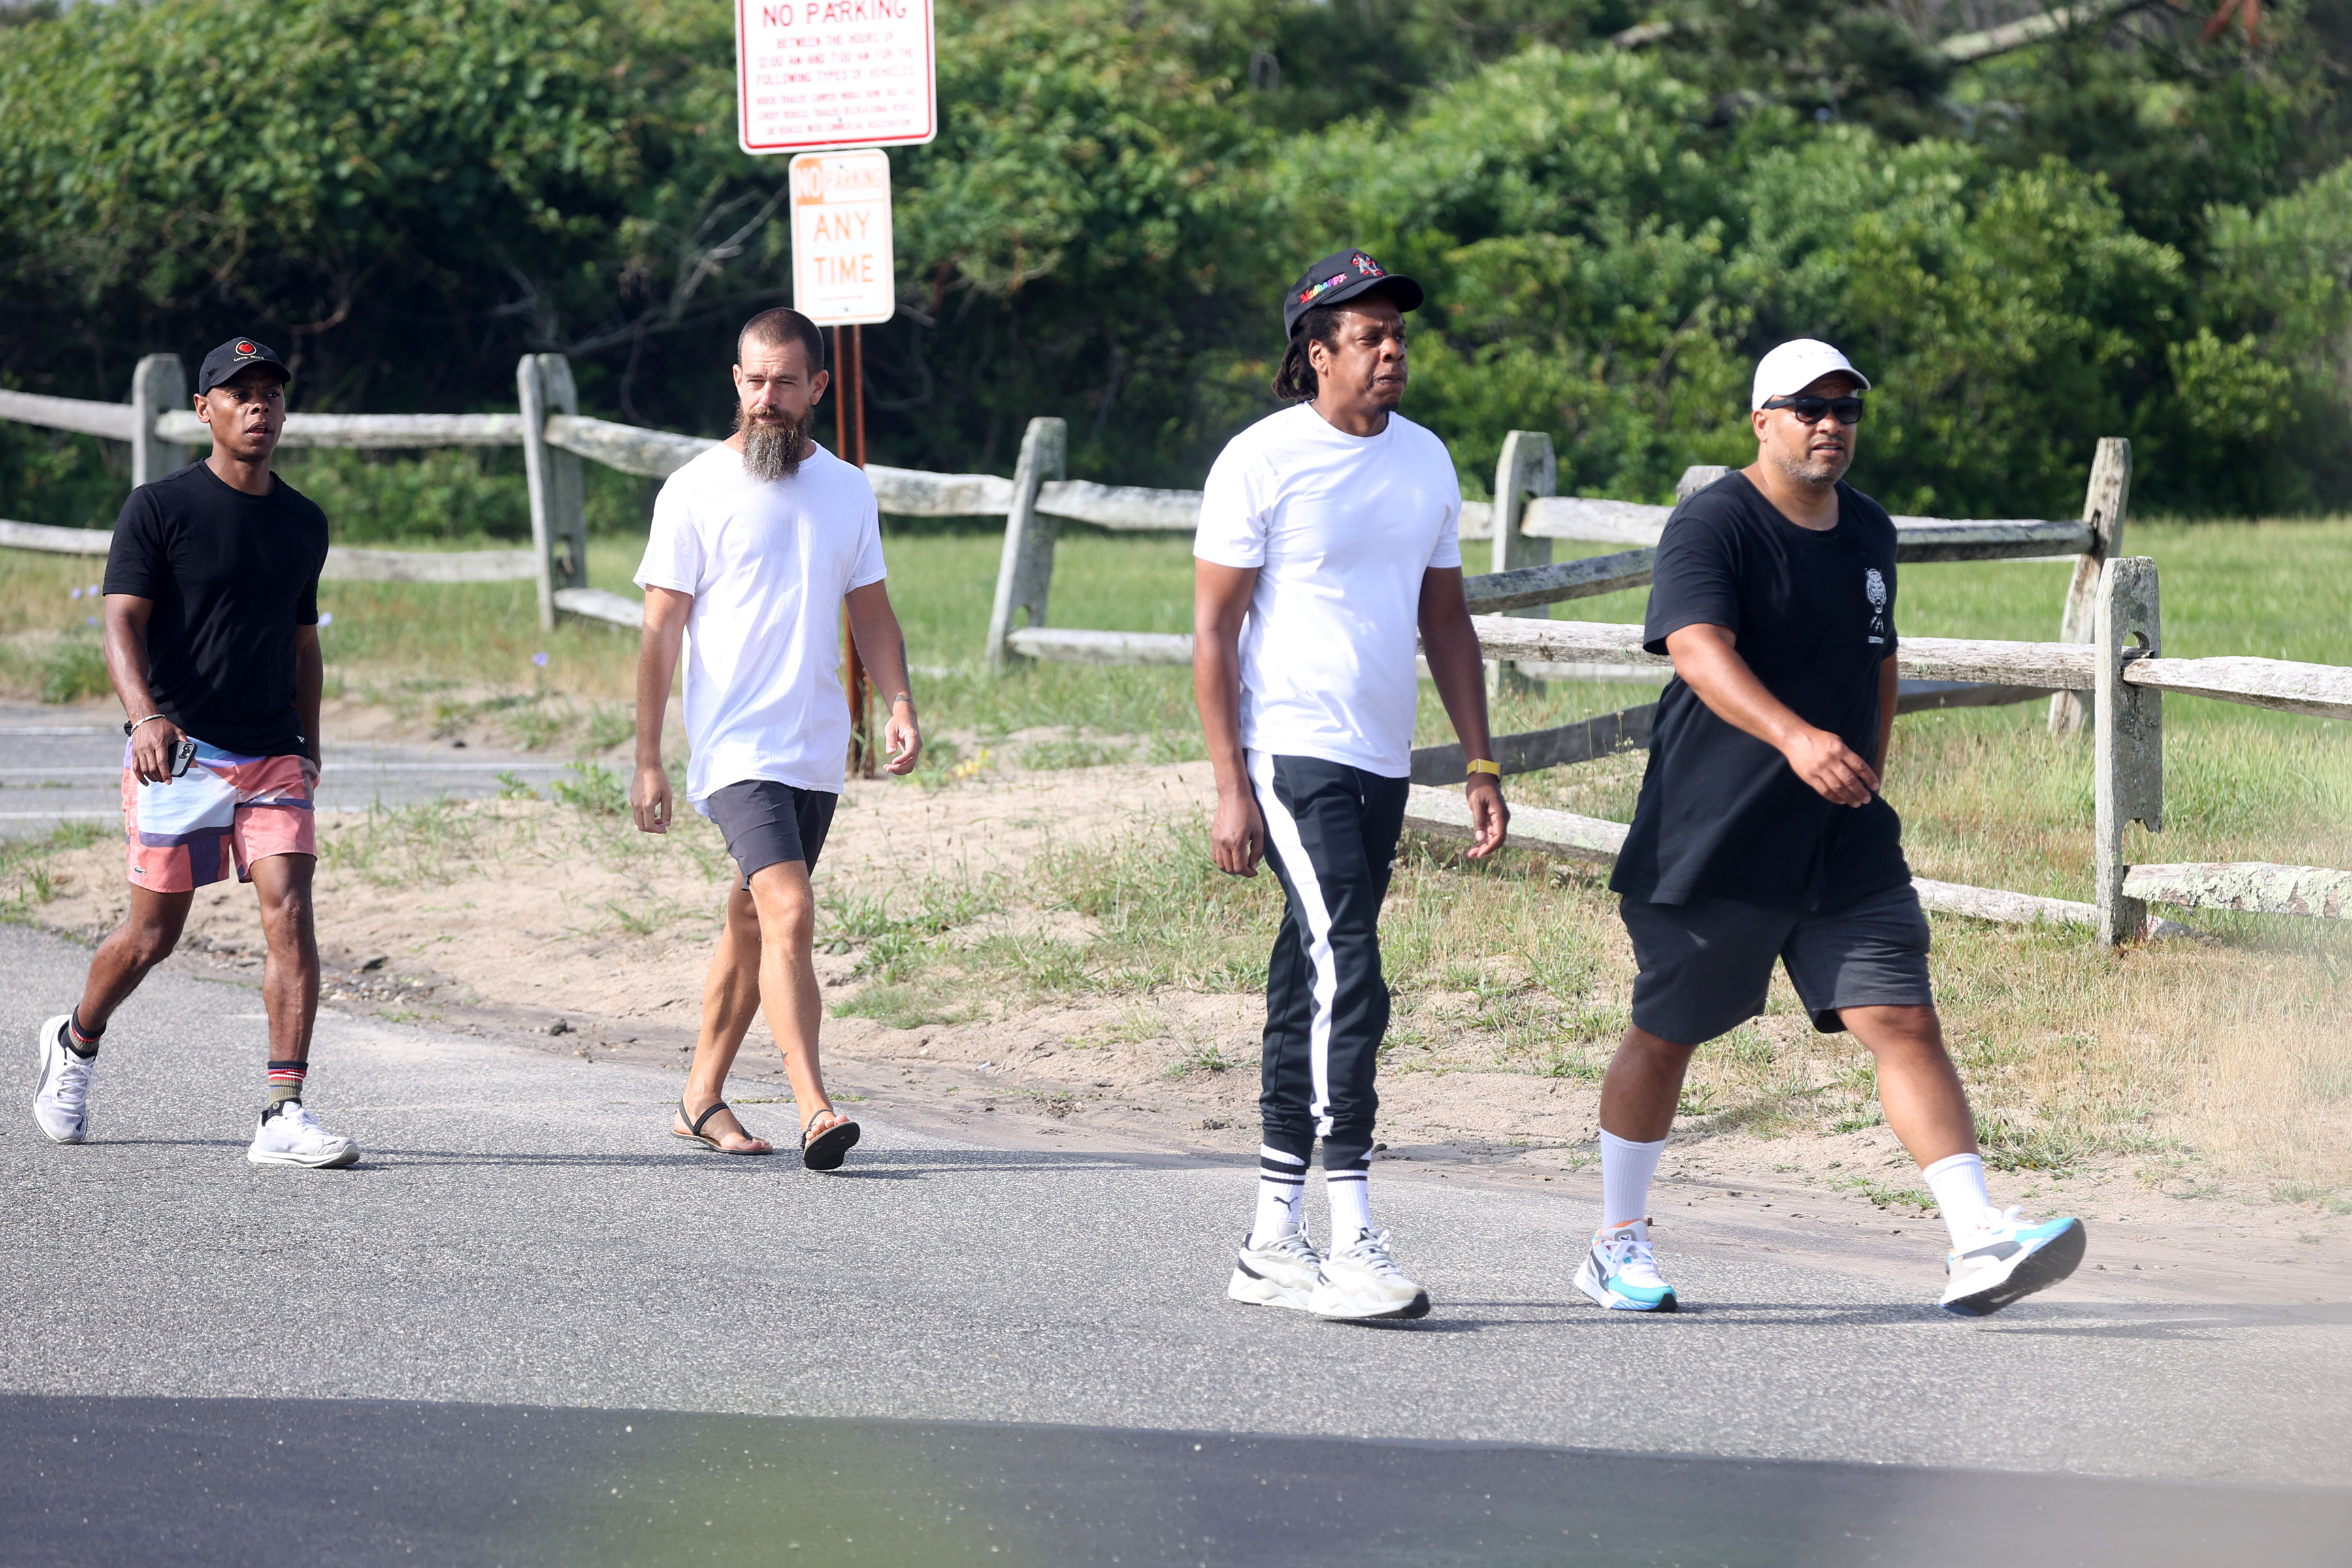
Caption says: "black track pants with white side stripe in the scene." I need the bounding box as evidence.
[1247,752,1411,1171]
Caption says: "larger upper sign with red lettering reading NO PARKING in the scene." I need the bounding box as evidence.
[736,0,938,153]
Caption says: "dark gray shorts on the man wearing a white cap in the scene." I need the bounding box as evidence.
[1618,881,1936,1046]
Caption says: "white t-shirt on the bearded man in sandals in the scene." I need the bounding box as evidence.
[638,447,885,816]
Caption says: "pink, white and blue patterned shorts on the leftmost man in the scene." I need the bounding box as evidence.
[122,740,318,893]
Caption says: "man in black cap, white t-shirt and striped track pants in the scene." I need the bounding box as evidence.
[1192,252,1510,1319]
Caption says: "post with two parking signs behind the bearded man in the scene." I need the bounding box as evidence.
[736,0,938,778]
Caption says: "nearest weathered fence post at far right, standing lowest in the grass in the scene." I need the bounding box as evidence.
[2091,555,2164,947]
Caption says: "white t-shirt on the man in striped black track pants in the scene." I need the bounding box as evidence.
[1192,402,1463,778]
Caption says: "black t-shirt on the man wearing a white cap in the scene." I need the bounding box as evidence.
[1609,472,1910,910]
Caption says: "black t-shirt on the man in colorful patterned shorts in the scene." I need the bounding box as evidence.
[106,463,327,757]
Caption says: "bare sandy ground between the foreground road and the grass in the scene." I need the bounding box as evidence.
[31,747,2352,1302]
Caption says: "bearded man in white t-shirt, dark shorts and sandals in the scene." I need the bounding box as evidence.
[630,310,922,1171]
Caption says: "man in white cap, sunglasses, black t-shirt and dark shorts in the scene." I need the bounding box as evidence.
[1576,338,2084,1316]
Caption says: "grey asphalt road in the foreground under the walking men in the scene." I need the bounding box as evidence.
[0,928,2352,1563]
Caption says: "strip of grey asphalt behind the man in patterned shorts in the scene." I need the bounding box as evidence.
[0,703,583,840]
